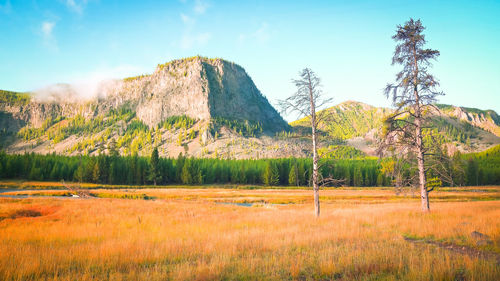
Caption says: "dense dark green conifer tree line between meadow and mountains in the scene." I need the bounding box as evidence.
[0,146,500,187]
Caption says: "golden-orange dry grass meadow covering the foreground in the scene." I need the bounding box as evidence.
[0,183,500,280]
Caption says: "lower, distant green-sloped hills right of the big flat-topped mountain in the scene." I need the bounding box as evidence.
[290,101,500,155]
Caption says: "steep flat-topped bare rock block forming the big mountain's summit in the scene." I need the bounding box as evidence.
[125,57,287,131]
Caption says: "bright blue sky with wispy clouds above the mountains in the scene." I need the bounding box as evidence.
[0,0,500,120]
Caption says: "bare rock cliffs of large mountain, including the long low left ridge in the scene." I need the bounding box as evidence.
[0,57,288,132]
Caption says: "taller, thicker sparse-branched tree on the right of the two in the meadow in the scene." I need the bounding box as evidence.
[385,19,443,212]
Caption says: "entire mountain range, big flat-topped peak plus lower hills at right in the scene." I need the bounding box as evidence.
[0,57,500,159]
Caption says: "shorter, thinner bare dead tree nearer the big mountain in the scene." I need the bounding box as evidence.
[278,68,331,217]
